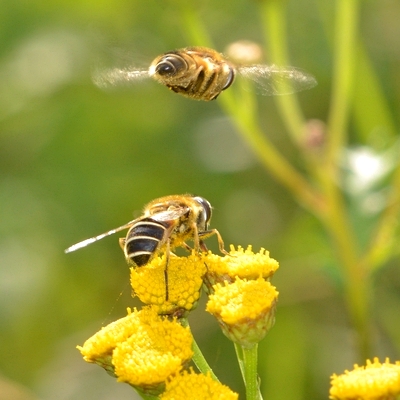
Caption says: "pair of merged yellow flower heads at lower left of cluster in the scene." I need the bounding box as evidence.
[79,307,193,393]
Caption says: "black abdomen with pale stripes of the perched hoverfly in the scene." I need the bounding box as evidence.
[124,218,170,267]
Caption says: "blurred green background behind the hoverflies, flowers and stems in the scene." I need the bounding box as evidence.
[0,0,400,400]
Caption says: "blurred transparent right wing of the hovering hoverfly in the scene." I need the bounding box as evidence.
[238,64,317,96]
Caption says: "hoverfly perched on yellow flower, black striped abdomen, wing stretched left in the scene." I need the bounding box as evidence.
[65,194,226,300]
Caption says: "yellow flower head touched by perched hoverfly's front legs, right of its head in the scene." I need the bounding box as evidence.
[203,245,279,290]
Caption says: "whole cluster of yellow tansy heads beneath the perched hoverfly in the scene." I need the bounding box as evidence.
[78,246,278,400]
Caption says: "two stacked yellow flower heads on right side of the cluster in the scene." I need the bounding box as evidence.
[204,246,278,348]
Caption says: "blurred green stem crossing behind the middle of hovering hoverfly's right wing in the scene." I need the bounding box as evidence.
[260,0,305,145]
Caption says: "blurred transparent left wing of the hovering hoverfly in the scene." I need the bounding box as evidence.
[92,68,149,89]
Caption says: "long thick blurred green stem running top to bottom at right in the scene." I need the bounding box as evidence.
[319,0,370,359]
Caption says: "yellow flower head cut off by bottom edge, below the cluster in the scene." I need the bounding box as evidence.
[160,371,238,400]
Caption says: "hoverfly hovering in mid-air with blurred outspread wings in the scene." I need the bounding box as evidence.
[93,47,317,101]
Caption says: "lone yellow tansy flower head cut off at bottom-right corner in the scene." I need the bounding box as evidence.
[329,357,400,400]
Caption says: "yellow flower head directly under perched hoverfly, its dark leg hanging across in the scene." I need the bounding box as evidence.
[131,253,206,315]
